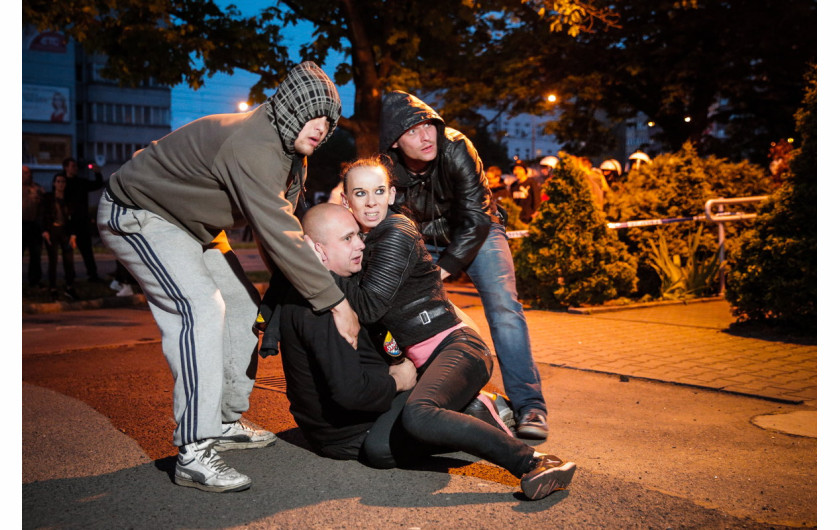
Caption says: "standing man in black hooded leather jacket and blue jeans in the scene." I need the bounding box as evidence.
[379,91,548,439]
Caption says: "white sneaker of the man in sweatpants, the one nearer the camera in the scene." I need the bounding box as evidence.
[175,439,251,493]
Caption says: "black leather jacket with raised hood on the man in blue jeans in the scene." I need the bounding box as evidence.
[379,91,504,274]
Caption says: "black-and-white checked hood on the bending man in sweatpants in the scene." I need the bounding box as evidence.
[264,61,341,155]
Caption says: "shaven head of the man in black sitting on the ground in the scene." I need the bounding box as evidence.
[301,203,365,276]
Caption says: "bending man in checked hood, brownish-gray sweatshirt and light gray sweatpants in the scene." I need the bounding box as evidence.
[97,62,359,492]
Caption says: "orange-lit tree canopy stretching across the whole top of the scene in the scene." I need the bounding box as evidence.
[23,0,816,161]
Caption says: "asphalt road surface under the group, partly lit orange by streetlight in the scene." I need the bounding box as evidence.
[22,309,817,528]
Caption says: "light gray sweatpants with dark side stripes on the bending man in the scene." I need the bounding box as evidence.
[97,191,259,446]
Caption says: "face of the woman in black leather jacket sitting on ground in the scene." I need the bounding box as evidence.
[341,166,397,232]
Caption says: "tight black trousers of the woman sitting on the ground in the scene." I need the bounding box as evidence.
[360,327,534,477]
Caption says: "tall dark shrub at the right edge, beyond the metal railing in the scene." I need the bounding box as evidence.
[726,67,817,332]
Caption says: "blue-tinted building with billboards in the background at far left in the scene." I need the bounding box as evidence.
[22,27,172,190]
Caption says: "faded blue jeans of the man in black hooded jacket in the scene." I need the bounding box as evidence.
[426,223,547,418]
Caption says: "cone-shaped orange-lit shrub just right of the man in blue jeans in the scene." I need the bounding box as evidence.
[514,153,636,308]
